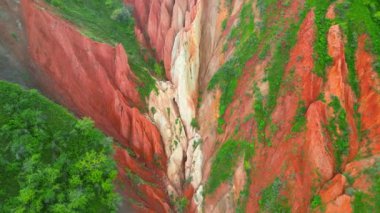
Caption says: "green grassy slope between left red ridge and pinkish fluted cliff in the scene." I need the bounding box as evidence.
[46,0,164,98]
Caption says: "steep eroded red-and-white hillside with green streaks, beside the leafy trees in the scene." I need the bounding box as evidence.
[1,0,380,212]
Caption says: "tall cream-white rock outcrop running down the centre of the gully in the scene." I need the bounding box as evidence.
[149,1,203,208]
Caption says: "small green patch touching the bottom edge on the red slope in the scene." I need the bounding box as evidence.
[259,178,290,213]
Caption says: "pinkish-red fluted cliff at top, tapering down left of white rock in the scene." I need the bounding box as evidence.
[124,0,197,79]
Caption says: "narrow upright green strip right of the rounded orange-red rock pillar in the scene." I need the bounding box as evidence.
[327,96,350,171]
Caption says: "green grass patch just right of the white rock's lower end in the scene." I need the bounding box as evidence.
[205,140,254,194]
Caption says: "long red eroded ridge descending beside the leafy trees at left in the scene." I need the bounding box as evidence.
[22,0,170,210]
